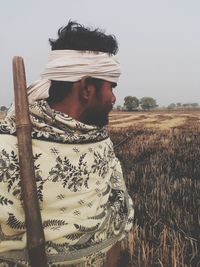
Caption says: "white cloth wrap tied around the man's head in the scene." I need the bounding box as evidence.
[28,50,120,103]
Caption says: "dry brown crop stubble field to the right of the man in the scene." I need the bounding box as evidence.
[109,111,200,267]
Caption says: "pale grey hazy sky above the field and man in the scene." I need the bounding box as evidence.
[0,0,200,106]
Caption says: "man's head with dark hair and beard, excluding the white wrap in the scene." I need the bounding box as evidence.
[47,21,118,126]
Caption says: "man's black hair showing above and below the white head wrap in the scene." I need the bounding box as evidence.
[47,21,118,104]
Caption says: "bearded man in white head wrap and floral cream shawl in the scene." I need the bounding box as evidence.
[0,21,133,267]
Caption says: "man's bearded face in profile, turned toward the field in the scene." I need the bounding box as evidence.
[85,81,116,127]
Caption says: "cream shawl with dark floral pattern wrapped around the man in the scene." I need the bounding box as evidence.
[0,100,133,266]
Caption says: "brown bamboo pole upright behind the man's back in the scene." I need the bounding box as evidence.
[13,57,47,267]
